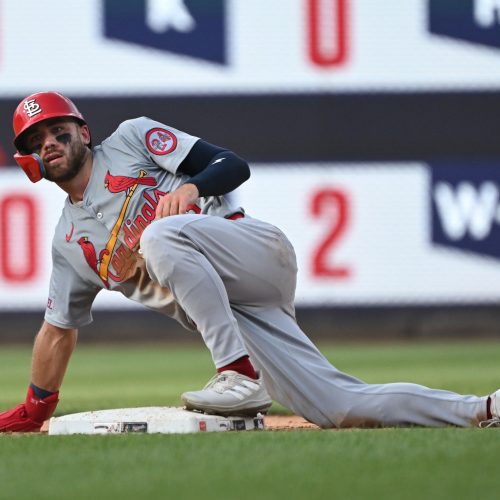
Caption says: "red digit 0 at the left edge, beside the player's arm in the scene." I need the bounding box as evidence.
[0,194,38,283]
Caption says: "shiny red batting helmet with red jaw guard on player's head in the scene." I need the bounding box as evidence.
[12,92,87,182]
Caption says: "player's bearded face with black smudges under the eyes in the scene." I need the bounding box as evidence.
[24,118,90,182]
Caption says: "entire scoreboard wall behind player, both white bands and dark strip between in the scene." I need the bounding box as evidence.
[0,0,500,310]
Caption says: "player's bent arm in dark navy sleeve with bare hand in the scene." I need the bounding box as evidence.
[156,139,250,219]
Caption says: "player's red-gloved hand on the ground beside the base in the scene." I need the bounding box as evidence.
[0,387,59,432]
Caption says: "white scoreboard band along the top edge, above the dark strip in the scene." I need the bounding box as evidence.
[0,0,500,97]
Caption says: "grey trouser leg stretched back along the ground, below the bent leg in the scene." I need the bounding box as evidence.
[233,306,486,427]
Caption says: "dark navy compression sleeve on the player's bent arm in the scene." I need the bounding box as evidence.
[177,139,250,196]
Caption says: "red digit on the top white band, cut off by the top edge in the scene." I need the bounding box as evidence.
[307,0,348,67]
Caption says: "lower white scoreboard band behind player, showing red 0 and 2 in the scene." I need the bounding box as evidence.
[0,161,500,309]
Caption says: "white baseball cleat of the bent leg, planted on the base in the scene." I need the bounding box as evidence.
[181,370,272,416]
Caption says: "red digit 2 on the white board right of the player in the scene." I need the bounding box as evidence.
[310,188,352,279]
